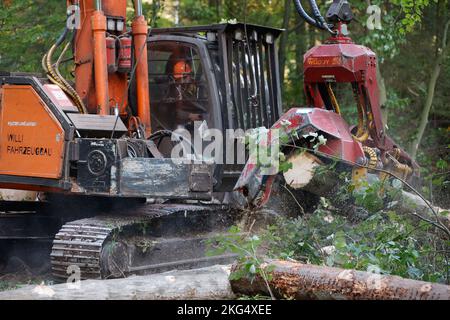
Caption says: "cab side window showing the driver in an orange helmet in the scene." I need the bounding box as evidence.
[148,41,210,131]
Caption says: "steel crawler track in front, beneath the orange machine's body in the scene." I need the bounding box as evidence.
[51,205,235,280]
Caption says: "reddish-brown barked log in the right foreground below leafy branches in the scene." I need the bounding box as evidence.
[231,261,450,300]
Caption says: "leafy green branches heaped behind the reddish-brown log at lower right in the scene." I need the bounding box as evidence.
[212,175,450,283]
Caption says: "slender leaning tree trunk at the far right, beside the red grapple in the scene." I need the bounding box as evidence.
[410,20,450,159]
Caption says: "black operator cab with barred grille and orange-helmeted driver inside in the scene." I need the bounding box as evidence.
[130,23,282,191]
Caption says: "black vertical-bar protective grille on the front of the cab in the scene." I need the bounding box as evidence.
[226,30,281,130]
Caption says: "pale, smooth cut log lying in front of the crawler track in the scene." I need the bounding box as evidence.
[0,266,234,300]
